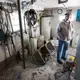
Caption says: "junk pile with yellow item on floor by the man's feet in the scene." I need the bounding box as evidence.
[54,55,76,80]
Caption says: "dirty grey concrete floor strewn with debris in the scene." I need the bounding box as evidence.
[0,48,76,80]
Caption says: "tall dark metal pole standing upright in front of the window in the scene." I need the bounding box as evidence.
[17,0,25,69]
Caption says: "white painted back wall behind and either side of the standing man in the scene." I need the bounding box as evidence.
[51,8,80,48]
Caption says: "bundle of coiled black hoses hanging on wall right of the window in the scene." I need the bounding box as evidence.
[24,9,37,37]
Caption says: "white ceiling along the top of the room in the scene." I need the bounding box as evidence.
[0,0,80,8]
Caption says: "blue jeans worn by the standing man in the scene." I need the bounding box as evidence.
[57,40,68,62]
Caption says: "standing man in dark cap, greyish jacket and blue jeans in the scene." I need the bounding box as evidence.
[57,13,73,64]
